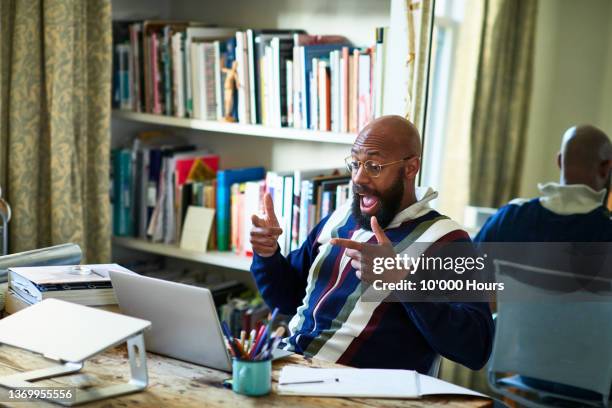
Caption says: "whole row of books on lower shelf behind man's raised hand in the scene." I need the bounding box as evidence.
[111,134,351,256]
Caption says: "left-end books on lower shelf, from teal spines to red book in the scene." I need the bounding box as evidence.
[111,132,219,247]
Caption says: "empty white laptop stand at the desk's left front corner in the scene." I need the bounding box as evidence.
[0,299,151,406]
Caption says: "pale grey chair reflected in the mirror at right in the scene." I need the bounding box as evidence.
[488,260,612,407]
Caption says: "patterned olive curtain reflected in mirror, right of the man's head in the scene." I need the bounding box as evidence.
[470,0,538,207]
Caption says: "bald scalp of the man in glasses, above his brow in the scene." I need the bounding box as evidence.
[355,115,421,157]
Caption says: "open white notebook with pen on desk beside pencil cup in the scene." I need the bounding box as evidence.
[278,366,488,398]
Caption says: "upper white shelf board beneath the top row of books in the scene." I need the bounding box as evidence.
[113,109,355,145]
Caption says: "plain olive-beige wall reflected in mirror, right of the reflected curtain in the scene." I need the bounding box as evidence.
[520,0,612,197]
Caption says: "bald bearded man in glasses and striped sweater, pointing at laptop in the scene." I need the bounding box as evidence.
[251,116,493,373]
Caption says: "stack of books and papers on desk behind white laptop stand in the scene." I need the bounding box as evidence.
[5,264,131,314]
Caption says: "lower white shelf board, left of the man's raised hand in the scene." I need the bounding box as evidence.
[113,237,251,271]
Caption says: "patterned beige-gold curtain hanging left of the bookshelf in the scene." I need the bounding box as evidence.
[0,0,112,263]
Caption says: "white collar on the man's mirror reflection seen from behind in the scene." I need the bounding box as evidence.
[538,183,606,215]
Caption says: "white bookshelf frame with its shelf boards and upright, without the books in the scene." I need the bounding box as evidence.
[112,0,408,273]
